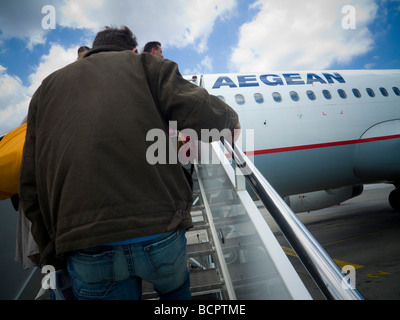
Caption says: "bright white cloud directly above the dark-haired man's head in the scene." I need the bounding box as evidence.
[58,0,236,53]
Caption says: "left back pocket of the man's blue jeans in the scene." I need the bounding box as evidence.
[68,248,114,299]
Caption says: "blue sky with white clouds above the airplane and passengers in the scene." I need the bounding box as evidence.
[0,0,400,134]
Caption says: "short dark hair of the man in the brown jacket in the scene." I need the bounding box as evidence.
[92,26,138,50]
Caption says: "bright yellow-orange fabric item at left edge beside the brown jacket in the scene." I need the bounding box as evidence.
[0,123,26,200]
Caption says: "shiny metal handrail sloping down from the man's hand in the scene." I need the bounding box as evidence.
[222,140,363,300]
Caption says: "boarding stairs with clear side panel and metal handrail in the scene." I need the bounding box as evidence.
[143,141,362,300]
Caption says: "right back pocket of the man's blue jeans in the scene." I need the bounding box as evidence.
[144,231,187,279]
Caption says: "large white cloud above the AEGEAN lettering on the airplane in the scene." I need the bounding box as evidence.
[230,0,377,72]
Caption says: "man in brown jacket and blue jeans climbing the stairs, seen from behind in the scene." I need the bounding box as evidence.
[20,27,240,299]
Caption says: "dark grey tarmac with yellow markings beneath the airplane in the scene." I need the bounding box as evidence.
[262,184,400,300]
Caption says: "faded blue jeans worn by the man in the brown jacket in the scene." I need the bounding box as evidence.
[68,230,191,300]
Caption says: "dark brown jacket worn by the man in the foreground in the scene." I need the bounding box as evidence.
[20,47,238,267]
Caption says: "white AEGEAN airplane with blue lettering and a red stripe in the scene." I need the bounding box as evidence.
[185,70,400,213]
